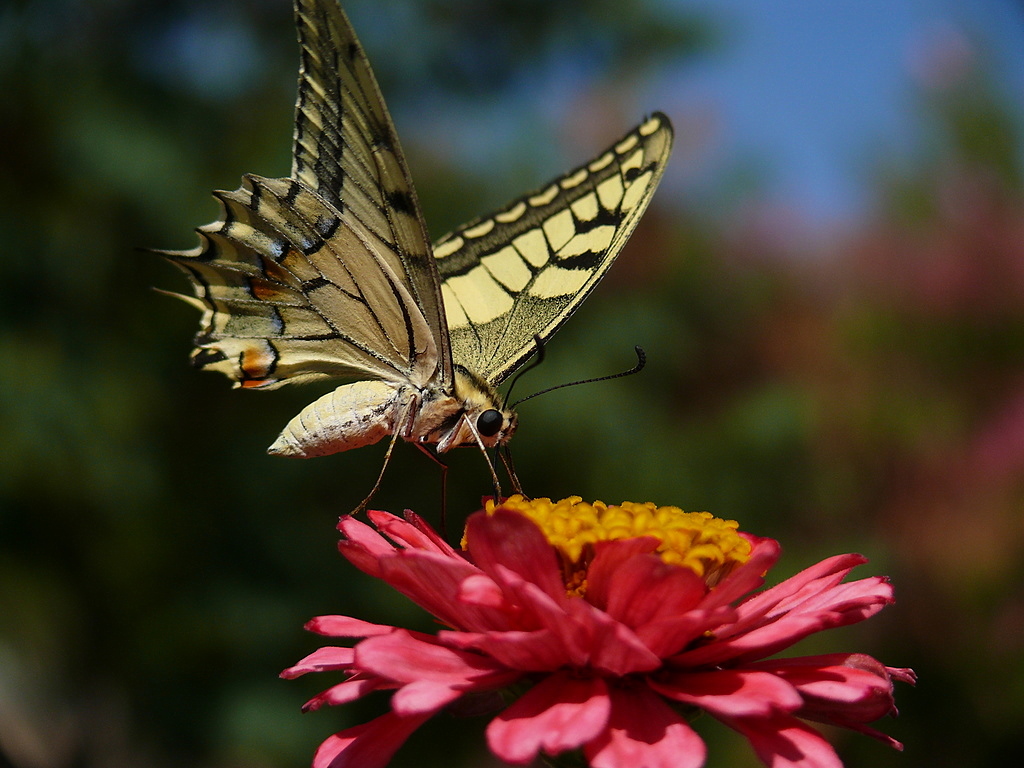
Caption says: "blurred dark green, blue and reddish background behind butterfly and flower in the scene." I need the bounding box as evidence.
[0,0,1024,768]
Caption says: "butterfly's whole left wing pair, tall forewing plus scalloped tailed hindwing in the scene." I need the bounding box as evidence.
[160,0,453,388]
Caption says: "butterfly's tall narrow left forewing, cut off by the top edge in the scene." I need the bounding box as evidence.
[292,0,452,384]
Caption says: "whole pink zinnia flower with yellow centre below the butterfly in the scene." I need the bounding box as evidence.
[282,497,914,768]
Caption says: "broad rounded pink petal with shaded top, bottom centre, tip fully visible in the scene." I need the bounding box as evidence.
[487,673,611,764]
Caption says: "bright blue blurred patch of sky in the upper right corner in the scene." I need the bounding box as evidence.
[663,0,1024,227]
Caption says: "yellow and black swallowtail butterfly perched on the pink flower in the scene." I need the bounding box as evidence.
[159,0,673,488]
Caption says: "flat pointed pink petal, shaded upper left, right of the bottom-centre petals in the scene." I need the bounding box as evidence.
[650,670,804,718]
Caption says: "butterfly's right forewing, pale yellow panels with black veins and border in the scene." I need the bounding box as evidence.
[434,114,672,384]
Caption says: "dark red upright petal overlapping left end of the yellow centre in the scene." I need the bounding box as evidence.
[466,509,567,600]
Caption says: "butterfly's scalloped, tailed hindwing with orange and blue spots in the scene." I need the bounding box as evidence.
[158,175,437,388]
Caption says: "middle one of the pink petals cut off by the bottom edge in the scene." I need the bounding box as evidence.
[584,687,707,768]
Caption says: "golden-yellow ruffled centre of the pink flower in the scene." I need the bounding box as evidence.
[486,495,751,595]
